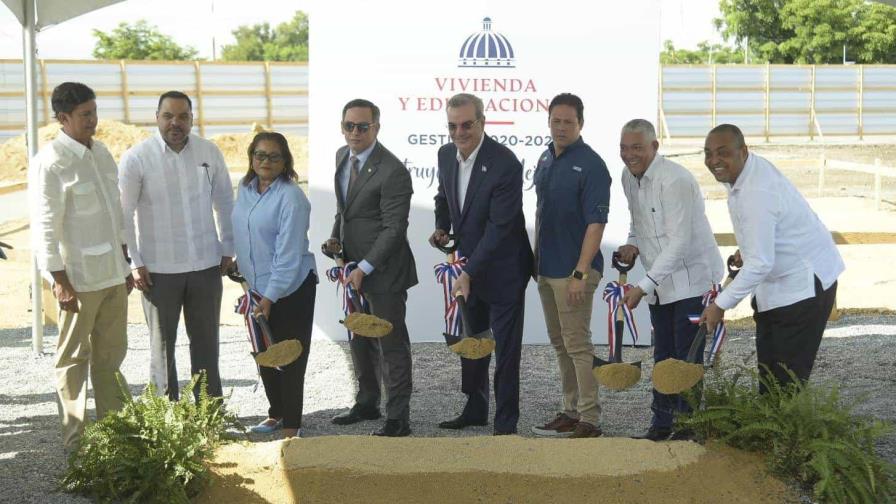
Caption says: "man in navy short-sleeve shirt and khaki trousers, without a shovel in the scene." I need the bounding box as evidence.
[532,93,611,438]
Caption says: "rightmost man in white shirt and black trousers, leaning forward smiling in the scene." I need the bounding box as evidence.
[701,124,845,391]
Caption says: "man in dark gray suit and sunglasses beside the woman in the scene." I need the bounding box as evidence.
[324,99,417,437]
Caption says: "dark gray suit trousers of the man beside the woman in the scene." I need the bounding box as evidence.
[349,291,413,420]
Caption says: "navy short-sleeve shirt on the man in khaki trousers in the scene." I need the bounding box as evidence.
[535,137,612,278]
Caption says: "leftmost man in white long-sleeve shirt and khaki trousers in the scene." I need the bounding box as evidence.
[32,82,134,450]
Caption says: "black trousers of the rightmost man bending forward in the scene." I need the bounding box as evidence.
[753,277,837,393]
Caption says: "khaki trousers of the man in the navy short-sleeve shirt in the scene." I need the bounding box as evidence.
[538,269,601,425]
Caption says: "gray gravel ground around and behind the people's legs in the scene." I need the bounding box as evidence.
[0,315,896,503]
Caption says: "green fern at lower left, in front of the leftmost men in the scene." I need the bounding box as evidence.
[60,373,240,504]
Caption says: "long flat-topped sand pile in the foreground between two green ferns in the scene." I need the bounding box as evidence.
[195,436,796,504]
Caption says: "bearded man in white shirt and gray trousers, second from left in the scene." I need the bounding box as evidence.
[119,91,233,400]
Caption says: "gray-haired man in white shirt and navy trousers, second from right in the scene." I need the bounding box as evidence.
[619,119,722,441]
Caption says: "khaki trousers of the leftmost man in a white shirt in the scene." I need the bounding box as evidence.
[56,283,128,448]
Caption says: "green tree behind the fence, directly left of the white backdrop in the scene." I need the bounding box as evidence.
[221,11,308,61]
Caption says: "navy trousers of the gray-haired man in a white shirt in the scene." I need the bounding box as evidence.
[649,296,706,428]
